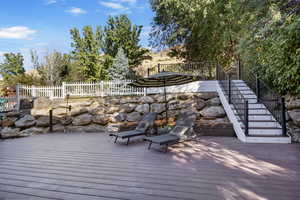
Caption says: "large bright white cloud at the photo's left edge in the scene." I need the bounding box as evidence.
[0,26,37,39]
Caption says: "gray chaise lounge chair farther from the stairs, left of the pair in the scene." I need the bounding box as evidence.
[109,112,157,145]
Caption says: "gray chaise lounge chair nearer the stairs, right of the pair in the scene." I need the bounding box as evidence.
[144,113,196,152]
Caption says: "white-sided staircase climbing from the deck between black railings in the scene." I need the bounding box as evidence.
[218,80,291,143]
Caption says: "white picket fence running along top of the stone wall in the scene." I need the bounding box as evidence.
[19,80,146,99]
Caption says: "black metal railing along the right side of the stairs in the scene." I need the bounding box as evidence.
[239,65,286,135]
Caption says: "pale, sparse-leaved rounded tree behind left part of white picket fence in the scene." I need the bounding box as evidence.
[31,51,71,85]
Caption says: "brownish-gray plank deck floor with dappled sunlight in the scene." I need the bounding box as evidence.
[0,133,300,200]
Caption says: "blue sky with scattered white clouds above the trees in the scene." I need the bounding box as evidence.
[0,0,153,69]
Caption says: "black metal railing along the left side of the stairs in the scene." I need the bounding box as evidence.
[217,65,249,135]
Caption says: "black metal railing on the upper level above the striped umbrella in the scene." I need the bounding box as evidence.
[148,62,216,80]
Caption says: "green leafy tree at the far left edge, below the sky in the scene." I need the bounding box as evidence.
[0,53,25,80]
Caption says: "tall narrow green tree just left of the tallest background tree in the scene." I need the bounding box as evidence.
[70,26,105,81]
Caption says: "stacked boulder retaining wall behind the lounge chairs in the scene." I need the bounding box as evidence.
[1,92,229,138]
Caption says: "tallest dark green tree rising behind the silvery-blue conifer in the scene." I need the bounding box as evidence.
[102,15,149,68]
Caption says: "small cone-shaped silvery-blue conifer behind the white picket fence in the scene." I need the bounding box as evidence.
[108,48,130,80]
